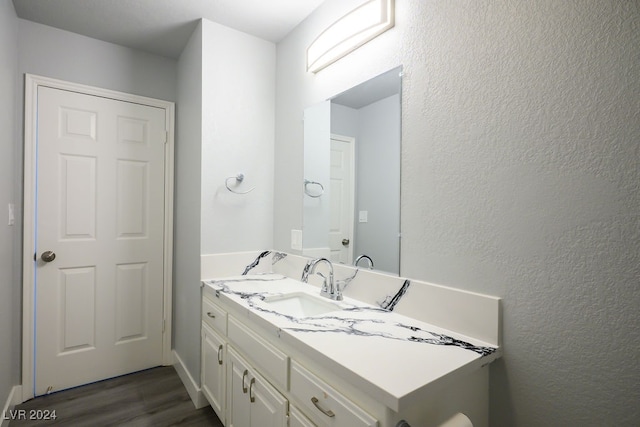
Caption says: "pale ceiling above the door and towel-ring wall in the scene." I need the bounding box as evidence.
[13,0,324,58]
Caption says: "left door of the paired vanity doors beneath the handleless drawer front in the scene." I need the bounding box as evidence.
[227,347,251,427]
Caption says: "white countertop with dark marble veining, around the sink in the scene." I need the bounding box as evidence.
[203,274,500,412]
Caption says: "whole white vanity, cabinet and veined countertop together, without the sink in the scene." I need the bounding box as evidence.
[195,275,504,427]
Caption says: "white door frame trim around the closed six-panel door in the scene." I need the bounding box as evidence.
[22,74,175,402]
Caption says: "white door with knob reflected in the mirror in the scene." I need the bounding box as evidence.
[329,135,355,264]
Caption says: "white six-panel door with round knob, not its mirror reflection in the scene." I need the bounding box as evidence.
[34,86,167,396]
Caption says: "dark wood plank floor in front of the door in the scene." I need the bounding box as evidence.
[7,366,223,427]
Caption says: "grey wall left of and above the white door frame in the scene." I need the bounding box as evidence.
[0,0,176,412]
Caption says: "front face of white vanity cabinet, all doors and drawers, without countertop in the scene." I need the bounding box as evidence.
[201,286,379,427]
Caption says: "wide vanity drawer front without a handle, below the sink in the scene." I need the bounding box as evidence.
[227,316,289,390]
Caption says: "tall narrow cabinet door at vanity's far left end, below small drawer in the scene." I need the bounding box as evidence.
[202,324,226,421]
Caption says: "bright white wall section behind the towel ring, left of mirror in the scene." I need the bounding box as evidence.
[201,20,276,254]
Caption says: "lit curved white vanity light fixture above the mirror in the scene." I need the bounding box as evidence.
[307,0,394,73]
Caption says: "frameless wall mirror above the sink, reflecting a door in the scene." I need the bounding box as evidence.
[302,67,402,274]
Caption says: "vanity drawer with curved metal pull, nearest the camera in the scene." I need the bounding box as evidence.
[291,361,378,427]
